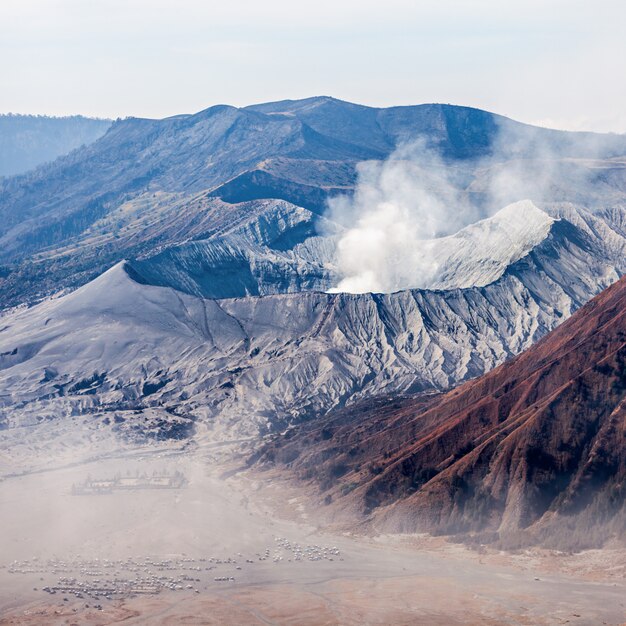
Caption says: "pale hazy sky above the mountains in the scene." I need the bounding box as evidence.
[0,0,626,132]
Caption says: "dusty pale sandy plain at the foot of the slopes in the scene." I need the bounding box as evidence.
[0,442,626,625]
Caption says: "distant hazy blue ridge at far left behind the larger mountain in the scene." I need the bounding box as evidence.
[0,114,112,177]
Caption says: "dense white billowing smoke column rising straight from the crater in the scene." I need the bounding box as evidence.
[329,143,481,293]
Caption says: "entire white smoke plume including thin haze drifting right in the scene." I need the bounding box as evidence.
[327,124,621,293]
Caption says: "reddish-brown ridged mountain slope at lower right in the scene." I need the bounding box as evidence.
[255,277,626,547]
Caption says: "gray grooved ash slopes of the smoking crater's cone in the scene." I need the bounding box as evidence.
[0,205,626,458]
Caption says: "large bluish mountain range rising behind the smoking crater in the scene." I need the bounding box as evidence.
[0,97,626,308]
